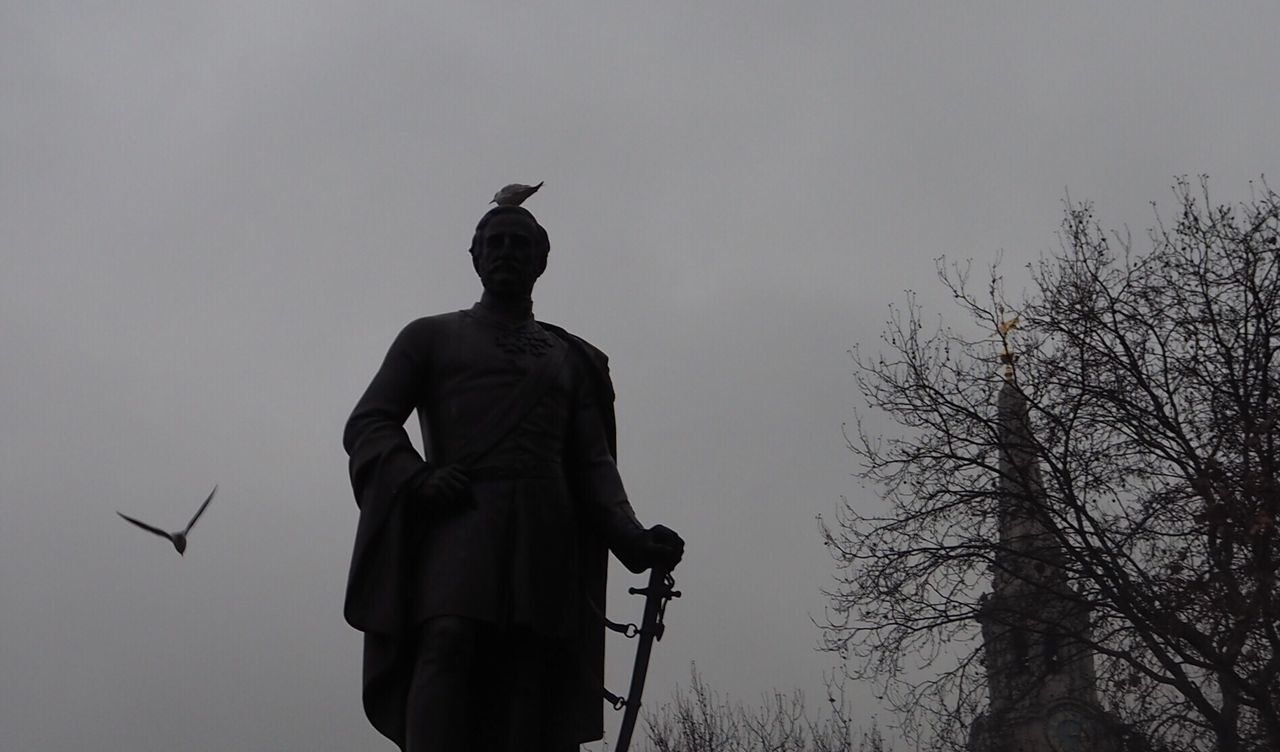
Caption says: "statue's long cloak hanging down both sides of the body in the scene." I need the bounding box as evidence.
[343,312,643,748]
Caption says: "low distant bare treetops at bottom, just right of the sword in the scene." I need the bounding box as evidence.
[645,666,886,752]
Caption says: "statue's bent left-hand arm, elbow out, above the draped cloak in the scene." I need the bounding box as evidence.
[342,320,430,503]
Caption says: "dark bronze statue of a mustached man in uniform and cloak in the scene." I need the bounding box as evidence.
[343,202,685,752]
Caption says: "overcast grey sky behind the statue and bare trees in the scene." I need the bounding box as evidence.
[0,0,1280,752]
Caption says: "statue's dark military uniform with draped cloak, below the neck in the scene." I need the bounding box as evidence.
[343,303,644,748]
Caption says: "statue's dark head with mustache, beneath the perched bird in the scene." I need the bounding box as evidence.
[471,206,552,298]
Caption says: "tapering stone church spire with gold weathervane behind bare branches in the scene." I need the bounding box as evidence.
[969,324,1116,752]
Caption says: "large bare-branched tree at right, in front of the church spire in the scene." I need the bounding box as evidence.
[822,178,1280,752]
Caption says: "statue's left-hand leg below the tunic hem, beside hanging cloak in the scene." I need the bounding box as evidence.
[406,616,483,752]
